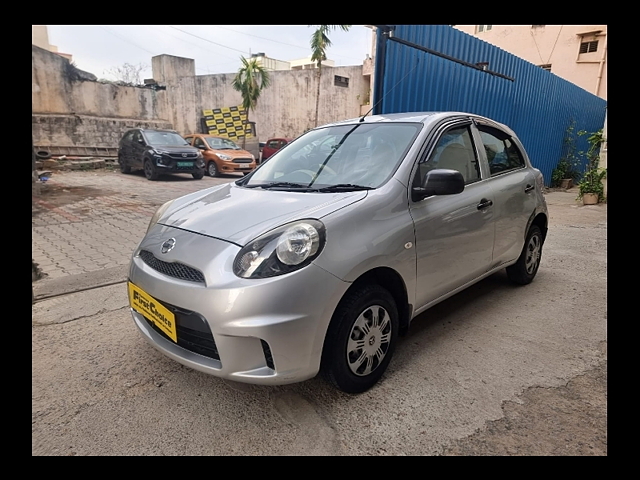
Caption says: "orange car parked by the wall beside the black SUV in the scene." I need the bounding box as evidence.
[184,133,257,177]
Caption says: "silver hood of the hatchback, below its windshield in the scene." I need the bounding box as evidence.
[158,183,367,246]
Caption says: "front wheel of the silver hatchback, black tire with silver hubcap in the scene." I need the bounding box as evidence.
[322,284,400,393]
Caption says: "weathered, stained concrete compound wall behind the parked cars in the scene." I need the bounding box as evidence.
[31,45,369,148]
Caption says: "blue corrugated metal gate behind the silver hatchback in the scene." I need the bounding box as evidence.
[373,25,607,185]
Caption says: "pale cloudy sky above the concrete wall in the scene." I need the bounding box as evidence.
[47,25,371,80]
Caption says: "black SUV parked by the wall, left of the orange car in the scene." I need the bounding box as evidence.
[118,128,204,180]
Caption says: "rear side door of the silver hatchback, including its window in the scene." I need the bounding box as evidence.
[476,121,537,267]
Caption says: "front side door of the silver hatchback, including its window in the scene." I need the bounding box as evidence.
[410,121,495,310]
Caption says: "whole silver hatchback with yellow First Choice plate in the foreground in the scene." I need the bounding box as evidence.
[128,112,548,393]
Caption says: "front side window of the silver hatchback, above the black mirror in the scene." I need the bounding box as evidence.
[413,126,480,187]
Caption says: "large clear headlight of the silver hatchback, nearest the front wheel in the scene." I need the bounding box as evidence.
[233,220,326,278]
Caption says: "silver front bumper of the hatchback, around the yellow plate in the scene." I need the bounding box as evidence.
[129,225,350,385]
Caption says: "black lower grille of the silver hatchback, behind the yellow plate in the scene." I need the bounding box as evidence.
[145,302,220,360]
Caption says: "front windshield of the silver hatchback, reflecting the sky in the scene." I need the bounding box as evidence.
[242,123,422,188]
